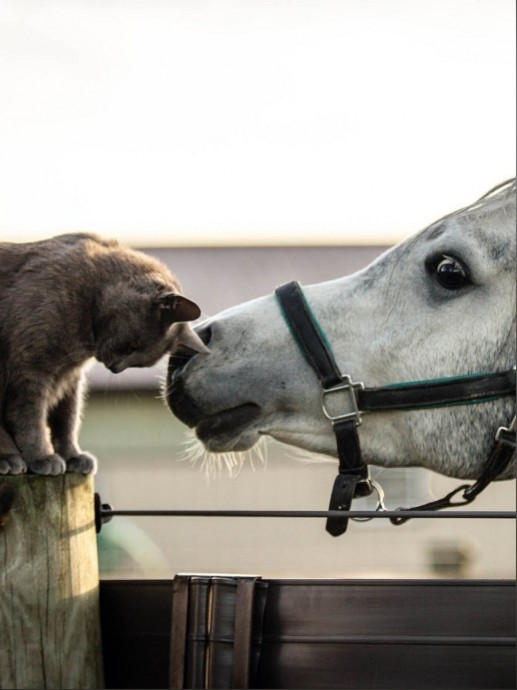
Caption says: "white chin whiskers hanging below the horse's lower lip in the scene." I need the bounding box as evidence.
[179,429,267,479]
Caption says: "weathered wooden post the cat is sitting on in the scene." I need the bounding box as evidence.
[0,474,104,689]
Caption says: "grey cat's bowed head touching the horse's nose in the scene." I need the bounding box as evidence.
[93,285,208,374]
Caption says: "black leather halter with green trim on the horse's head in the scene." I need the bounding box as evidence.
[275,282,517,537]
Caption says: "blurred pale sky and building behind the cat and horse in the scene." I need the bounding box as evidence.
[0,0,516,577]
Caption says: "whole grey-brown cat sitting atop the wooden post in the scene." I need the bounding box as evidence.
[0,233,208,475]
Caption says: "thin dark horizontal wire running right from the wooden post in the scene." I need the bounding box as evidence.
[101,507,517,520]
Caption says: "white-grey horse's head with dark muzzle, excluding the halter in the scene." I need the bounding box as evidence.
[166,180,516,490]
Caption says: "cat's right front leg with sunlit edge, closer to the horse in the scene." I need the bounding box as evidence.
[48,373,97,474]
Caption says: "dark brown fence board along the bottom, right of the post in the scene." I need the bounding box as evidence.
[100,575,516,690]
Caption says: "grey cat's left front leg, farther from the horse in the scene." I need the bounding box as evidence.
[4,379,66,475]
